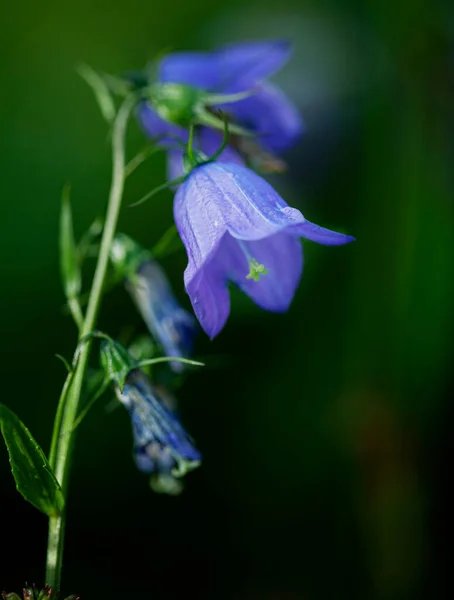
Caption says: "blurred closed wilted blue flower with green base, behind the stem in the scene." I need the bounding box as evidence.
[110,234,197,373]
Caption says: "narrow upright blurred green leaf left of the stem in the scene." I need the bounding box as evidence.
[60,186,82,300]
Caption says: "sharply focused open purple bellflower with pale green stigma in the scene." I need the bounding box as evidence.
[174,162,354,338]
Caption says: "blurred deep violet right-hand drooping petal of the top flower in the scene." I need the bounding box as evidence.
[225,83,304,153]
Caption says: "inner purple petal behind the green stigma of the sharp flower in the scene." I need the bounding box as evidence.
[219,232,303,312]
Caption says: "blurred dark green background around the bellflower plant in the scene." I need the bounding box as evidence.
[0,0,454,600]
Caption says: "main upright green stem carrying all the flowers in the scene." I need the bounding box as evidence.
[46,97,136,590]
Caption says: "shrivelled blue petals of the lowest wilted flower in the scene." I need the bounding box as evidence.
[116,370,201,477]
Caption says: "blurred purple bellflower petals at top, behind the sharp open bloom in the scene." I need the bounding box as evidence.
[138,41,303,179]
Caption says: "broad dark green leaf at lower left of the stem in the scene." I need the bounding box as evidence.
[0,404,65,517]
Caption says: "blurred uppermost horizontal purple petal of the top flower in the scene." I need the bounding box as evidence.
[159,40,291,92]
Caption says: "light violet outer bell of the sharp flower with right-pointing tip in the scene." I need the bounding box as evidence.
[174,162,354,260]
